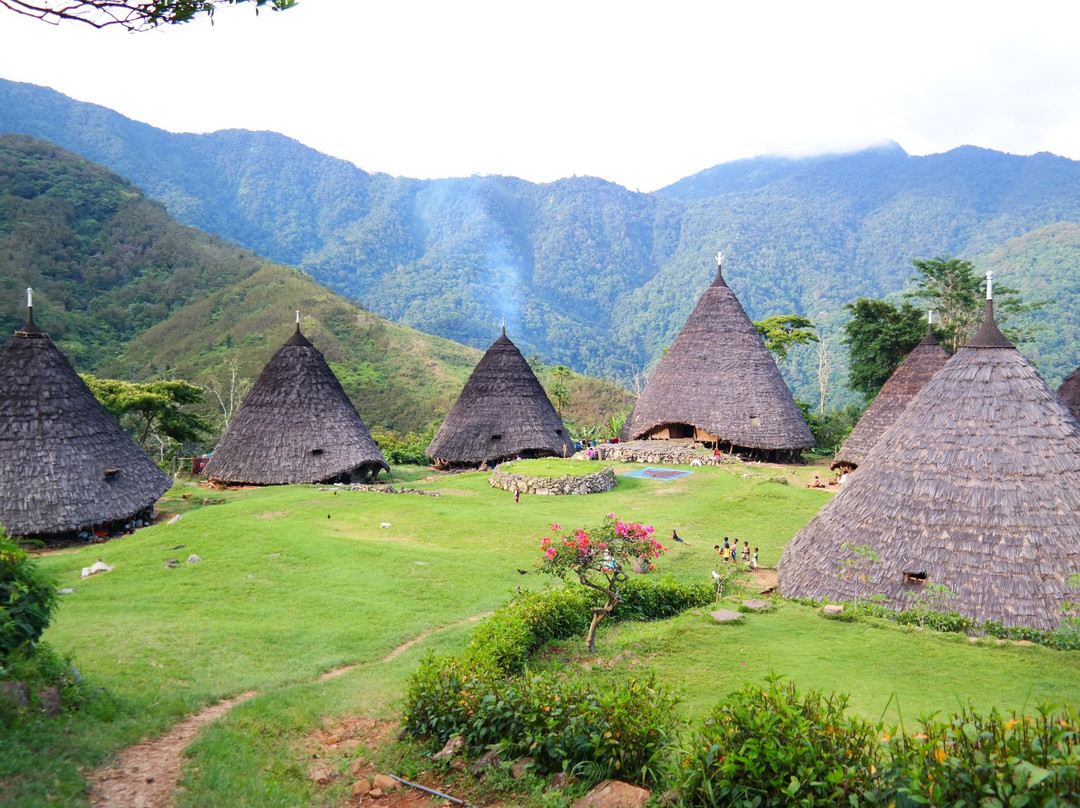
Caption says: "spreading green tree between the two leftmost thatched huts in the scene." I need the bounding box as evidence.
[82,374,213,454]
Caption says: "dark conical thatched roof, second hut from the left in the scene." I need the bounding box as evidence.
[204,323,390,485]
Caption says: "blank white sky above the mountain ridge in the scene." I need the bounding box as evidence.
[0,0,1080,191]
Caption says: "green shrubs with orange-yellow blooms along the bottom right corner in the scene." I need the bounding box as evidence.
[676,678,1080,808]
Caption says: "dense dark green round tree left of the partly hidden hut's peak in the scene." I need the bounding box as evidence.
[843,297,927,401]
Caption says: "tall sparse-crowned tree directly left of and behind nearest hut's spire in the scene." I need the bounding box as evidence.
[907,256,1053,353]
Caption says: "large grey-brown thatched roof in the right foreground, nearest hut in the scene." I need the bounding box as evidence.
[779,304,1080,629]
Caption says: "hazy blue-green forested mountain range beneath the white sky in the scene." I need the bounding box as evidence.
[0,81,1080,401]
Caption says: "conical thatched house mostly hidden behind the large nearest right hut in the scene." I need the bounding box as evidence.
[829,323,948,471]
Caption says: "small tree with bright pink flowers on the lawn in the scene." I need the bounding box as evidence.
[538,513,664,654]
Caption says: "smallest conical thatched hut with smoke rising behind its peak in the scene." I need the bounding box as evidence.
[427,328,573,468]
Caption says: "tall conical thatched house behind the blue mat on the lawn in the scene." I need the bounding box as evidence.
[621,259,814,460]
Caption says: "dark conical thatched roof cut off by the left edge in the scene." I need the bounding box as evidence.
[0,310,172,538]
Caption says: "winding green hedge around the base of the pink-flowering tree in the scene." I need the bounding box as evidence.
[404,578,713,782]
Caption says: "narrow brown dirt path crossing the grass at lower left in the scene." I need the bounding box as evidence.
[87,611,491,808]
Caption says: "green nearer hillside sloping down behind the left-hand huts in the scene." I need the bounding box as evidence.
[0,135,630,432]
